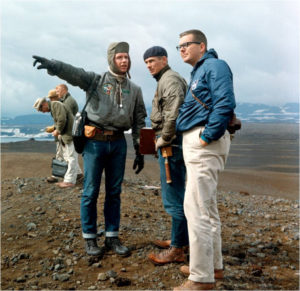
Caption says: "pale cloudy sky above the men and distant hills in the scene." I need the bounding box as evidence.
[0,0,300,117]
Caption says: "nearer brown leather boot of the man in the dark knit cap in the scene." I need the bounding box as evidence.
[148,247,185,265]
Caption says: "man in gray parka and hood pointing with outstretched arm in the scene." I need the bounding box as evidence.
[33,42,146,256]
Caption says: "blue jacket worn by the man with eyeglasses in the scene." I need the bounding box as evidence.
[176,49,235,143]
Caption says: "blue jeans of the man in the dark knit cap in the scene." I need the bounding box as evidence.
[158,136,189,248]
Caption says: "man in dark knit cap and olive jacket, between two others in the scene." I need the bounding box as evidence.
[144,46,188,265]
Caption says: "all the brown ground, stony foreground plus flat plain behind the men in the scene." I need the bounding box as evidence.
[1,124,299,290]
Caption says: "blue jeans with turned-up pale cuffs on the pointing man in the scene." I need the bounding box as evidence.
[80,138,127,238]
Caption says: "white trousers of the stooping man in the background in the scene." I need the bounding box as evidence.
[62,142,82,184]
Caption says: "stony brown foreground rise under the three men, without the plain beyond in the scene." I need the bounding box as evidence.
[1,178,299,290]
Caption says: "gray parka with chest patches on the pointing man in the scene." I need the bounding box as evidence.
[48,42,147,146]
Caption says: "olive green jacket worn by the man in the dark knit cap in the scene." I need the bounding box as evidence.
[150,69,187,141]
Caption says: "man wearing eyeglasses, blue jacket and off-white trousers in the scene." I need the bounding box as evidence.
[174,30,235,290]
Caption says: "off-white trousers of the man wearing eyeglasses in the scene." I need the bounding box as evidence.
[183,127,230,283]
